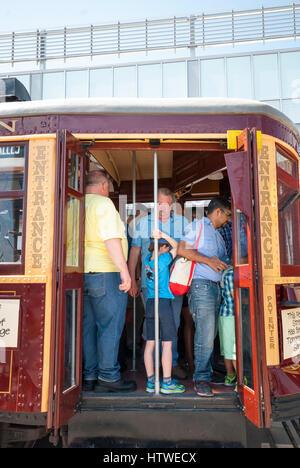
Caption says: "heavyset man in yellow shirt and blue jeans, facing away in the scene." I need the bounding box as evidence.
[83,170,136,393]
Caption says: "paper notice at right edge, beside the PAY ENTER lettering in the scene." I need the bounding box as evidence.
[281,307,300,359]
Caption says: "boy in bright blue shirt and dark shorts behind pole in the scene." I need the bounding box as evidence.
[144,231,185,394]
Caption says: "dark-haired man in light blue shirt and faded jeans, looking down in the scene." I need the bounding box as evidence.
[177,197,231,397]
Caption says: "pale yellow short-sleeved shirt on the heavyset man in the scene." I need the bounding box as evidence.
[84,193,128,273]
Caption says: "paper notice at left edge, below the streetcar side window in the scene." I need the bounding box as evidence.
[0,299,20,348]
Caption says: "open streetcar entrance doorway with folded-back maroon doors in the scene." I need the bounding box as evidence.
[54,130,262,429]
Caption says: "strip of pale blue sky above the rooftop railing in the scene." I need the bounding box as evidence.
[0,0,292,32]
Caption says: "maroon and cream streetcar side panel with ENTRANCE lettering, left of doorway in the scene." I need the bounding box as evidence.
[0,136,56,413]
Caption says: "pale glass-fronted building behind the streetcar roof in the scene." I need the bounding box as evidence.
[0,3,300,133]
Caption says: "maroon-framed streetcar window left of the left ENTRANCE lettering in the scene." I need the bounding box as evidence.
[0,143,26,264]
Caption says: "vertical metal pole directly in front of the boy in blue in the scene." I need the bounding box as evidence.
[153,151,159,395]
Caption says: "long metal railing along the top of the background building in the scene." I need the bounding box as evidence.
[0,3,300,64]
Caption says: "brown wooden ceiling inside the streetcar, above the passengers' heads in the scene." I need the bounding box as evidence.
[88,141,229,202]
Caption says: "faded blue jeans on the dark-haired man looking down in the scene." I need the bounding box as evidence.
[188,279,221,382]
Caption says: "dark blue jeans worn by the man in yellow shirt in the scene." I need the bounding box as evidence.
[82,273,127,382]
